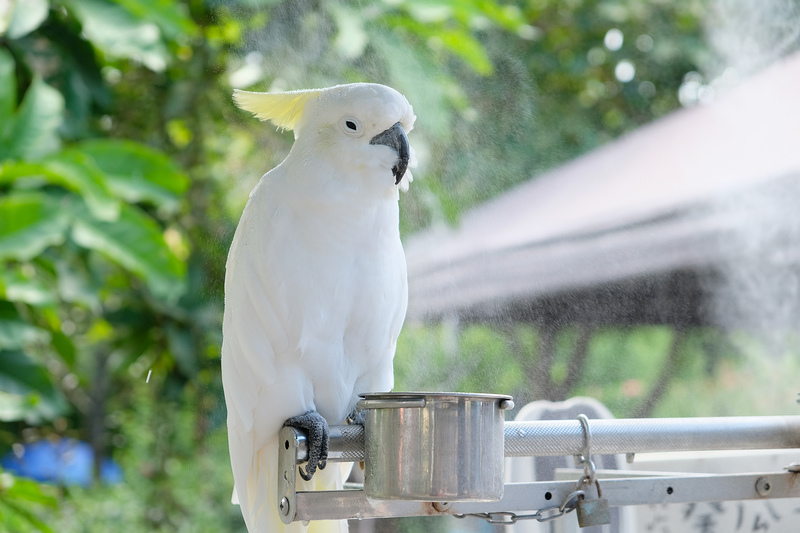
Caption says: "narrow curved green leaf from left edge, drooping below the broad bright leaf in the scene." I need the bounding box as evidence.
[0,150,119,220]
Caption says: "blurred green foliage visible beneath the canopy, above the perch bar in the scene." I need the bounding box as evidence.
[395,324,800,417]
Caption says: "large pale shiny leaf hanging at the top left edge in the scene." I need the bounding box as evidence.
[65,0,169,72]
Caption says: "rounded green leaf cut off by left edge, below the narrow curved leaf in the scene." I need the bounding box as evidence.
[0,192,66,261]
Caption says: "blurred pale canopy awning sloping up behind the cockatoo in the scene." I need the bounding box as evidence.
[406,54,800,323]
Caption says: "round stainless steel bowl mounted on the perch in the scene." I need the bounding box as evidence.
[358,392,514,502]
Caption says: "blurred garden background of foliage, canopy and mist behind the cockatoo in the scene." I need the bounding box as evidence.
[0,0,800,532]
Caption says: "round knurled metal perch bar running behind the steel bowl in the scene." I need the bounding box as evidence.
[297,416,800,462]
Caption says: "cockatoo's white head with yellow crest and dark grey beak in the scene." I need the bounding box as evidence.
[234,83,416,190]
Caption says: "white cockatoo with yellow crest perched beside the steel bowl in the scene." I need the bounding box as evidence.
[222,83,416,533]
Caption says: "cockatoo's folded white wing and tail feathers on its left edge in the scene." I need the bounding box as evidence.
[222,169,349,533]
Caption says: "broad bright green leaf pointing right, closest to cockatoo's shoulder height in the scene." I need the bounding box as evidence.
[77,139,189,211]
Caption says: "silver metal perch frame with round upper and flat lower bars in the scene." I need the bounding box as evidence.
[276,416,800,524]
